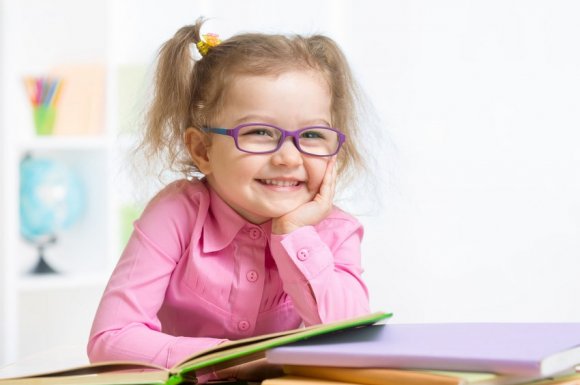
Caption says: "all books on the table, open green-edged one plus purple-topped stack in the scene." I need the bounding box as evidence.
[0,312,580,385]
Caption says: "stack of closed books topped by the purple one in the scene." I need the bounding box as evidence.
[263,323,580,385]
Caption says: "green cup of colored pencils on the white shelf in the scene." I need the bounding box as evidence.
[24,77,62,135]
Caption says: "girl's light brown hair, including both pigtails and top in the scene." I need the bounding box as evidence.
[139,18,365,185]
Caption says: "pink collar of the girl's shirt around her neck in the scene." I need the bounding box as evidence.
[203,184,272,253]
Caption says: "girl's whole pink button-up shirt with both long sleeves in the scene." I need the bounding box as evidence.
[88,180,369,367]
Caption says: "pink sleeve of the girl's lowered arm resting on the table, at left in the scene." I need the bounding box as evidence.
[87,183,225,368]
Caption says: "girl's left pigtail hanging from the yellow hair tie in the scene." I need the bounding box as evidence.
[138,18,203,171]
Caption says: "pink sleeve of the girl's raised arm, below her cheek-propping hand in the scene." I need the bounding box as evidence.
[270,212,369,325]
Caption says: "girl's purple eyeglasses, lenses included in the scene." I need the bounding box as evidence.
[202,123,346,156]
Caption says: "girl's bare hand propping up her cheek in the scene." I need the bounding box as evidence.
[272,157,336,234]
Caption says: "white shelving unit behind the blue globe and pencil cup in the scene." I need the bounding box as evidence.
[0,0,120,366]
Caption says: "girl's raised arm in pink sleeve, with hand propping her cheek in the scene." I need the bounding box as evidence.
[271,158,369,325]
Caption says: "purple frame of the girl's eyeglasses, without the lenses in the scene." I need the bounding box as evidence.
[201,123,346,157]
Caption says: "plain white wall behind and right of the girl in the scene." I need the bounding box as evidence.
[123,0,580,322]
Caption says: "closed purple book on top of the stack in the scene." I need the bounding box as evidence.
[266,323,580,377]
